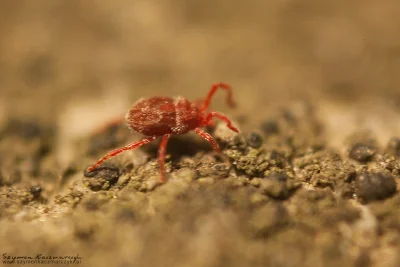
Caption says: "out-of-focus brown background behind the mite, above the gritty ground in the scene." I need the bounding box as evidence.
[0,0,400,138]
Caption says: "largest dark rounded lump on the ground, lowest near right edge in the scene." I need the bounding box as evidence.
[355,172,396,202]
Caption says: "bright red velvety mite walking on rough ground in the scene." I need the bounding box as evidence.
[87,82,239,182]
